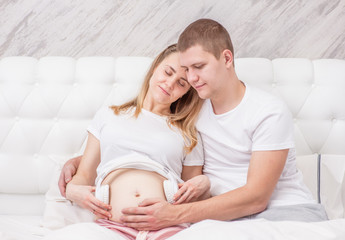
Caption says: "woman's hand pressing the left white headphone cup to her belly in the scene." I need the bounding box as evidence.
[66,183,111,219]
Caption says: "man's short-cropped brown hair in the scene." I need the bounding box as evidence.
[177,19,234,62]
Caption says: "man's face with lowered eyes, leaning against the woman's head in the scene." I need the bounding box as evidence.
[180,45,225,99]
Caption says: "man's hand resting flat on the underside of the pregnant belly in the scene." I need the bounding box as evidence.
[120,198,180,231]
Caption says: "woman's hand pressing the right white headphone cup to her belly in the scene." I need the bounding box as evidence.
[174,175,211,204]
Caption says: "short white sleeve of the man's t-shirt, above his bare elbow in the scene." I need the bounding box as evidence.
[252,99,295,151]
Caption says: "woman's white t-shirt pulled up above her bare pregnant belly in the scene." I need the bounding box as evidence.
[87,107,204,181]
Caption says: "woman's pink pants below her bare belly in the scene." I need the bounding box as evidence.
[96,219,189,240]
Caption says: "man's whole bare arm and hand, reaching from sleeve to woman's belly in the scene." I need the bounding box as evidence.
[121,149,289,230]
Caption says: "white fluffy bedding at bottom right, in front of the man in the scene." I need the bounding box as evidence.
[170,219,345,240]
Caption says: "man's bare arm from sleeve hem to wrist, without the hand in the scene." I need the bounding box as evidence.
[176,150,288,222]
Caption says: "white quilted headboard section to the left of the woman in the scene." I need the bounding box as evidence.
[0,57,152,215]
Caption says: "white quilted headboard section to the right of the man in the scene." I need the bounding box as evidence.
[236,58,345,155]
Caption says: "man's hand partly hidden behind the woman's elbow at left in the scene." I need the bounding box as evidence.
[58,156,82,197]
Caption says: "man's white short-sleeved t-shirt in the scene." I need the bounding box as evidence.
[197,85,314,207]
